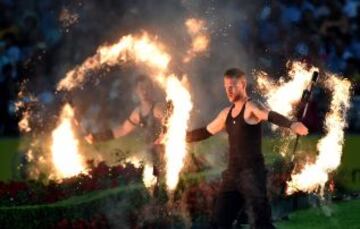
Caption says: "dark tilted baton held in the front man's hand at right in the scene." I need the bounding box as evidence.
[291,71,319,161]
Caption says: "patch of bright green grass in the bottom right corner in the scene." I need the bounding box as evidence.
[276,200,360,229]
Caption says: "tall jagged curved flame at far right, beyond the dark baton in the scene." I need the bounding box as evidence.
[286,75,351,195]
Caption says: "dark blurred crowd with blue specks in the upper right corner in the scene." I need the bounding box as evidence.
[241,0,360,81]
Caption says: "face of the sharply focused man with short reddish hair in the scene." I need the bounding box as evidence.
[224,77,246,103]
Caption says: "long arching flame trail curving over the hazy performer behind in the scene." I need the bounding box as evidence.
[57,33,192,190]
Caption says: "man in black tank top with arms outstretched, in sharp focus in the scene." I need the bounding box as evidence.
[186,68,308,229]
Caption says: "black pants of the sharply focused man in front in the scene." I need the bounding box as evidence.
[214,168,274,229]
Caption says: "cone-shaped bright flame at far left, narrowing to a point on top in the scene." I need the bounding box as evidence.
[51,104,85,178]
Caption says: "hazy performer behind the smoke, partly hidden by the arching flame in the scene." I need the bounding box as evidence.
[86,75,164,182]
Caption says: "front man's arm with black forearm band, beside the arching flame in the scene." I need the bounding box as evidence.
[186,108,229,142]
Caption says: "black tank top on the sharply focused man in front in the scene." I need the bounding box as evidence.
[226,103,264,171]
